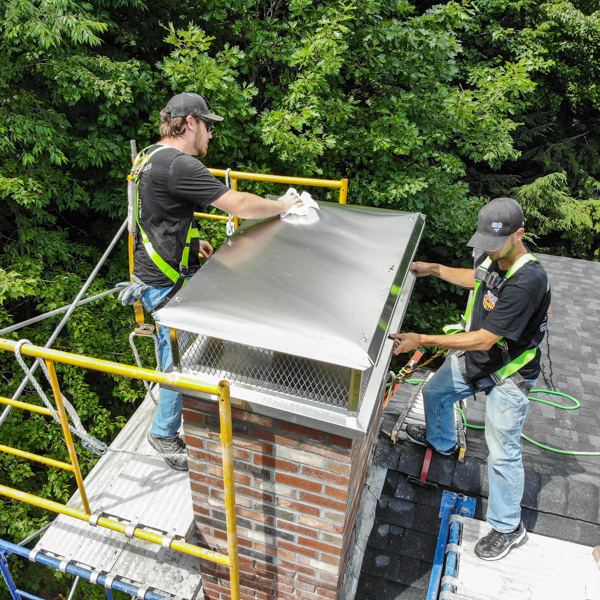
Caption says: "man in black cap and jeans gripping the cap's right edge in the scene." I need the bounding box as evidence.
[391,198,550,560]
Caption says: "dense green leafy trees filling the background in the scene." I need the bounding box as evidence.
[0,0,600,598]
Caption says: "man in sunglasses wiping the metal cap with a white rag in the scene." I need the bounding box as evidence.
[127,92,302,471]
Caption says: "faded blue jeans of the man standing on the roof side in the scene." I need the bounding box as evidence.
[423,356,537,533]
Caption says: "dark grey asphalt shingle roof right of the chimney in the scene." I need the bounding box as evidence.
[356,255,600,600]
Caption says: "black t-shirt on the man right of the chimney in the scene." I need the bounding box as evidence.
[465,254,550,381]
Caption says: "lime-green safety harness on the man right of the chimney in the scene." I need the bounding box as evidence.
[444,253,537,395]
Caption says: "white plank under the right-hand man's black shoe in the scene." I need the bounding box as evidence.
[456,519,600,600]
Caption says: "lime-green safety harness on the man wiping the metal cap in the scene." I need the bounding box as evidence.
[128,146,200,310]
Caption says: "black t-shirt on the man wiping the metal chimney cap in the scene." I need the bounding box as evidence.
[133,145,229,287]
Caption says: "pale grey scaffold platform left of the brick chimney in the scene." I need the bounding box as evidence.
[36,386,203,600]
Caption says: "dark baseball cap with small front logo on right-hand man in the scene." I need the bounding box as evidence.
[467,198,525,252]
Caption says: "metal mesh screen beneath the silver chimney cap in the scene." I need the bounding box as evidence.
[179,331,358,409]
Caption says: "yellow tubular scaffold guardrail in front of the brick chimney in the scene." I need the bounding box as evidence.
[0,338,240,600]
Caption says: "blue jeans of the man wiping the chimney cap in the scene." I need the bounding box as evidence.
[142,287,182,438]
